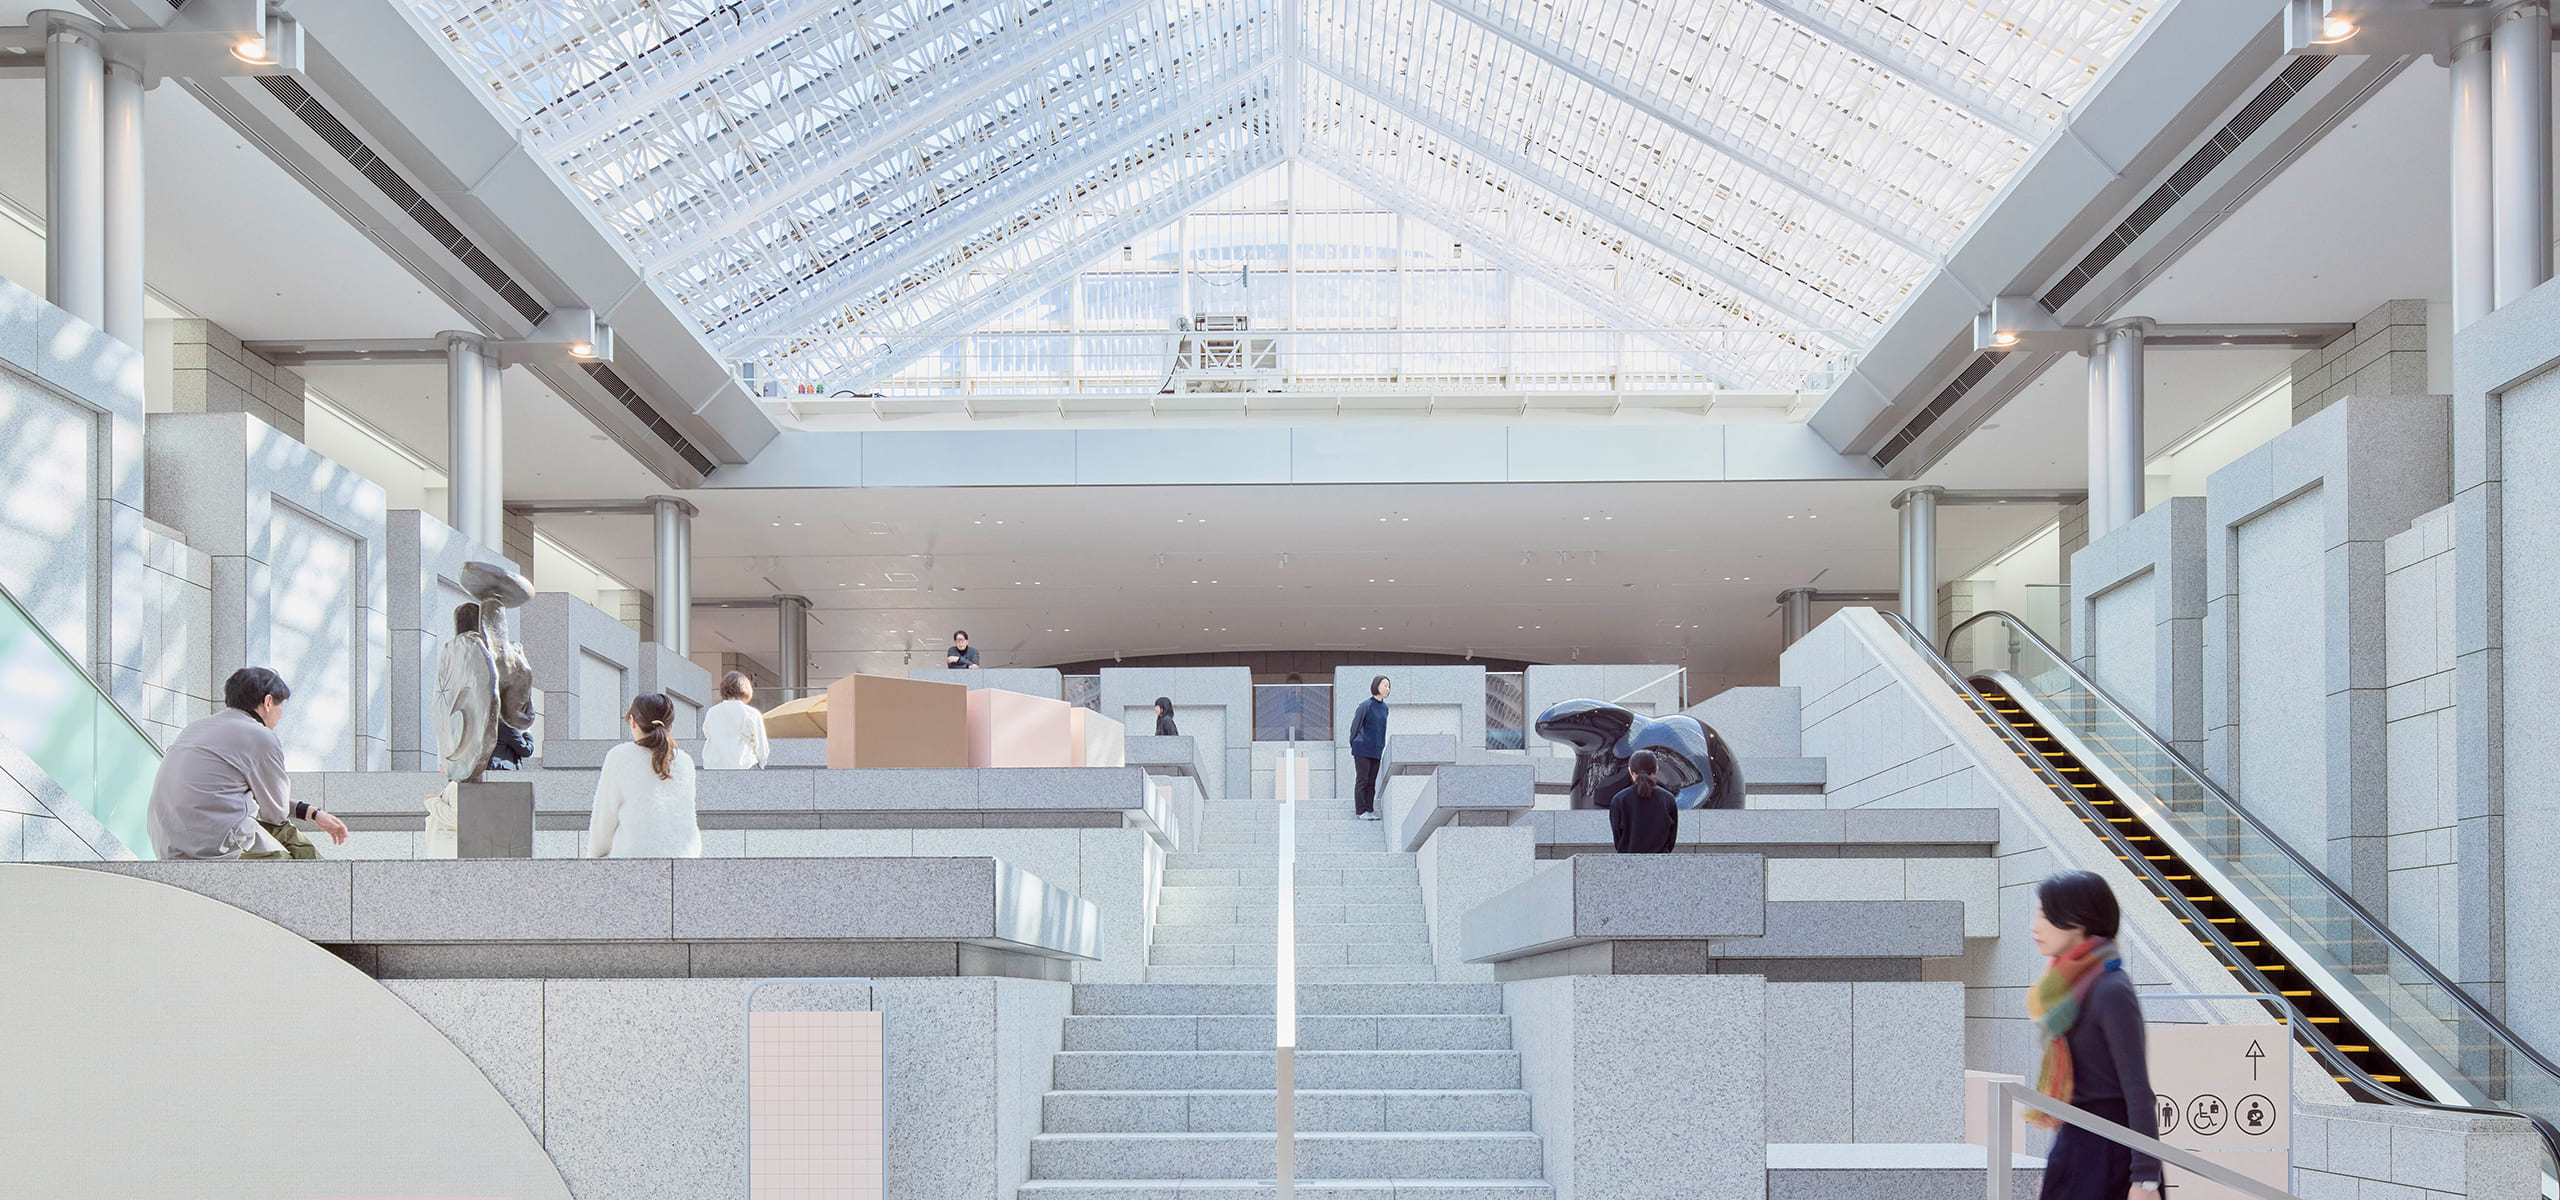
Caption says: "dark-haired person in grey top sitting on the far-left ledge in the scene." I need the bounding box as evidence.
[151,668,346,857]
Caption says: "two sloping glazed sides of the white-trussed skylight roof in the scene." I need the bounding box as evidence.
[410,0,2158,389]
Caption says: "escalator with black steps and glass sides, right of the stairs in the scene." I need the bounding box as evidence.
[1884,612,2560,1171]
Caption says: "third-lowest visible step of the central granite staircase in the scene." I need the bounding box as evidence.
[1039,1090,1528,1133]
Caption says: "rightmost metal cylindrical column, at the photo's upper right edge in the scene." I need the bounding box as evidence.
[2488,5,2552,307]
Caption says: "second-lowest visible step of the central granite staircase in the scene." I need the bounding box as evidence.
[1032,1133,1546,1180]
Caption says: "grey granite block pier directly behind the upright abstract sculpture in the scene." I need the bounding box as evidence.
[384,509,522,770]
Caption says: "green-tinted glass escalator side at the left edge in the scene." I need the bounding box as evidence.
[0,578,161,857]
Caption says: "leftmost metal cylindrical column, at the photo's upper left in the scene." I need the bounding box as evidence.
[44,26,108,328]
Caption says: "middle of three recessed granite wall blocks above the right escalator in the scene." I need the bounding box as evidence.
[2202,397,2452,911]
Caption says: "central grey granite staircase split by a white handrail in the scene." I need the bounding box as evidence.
[1016,801,1554,1200]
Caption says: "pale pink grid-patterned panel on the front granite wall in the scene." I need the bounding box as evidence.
[748,1013,883,1200]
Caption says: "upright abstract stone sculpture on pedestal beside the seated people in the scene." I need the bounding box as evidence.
[435,563,532,783]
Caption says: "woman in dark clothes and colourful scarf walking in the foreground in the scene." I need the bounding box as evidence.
[2028,870,2161,1200]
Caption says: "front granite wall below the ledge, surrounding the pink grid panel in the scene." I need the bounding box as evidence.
[381,977,1070,1200]
